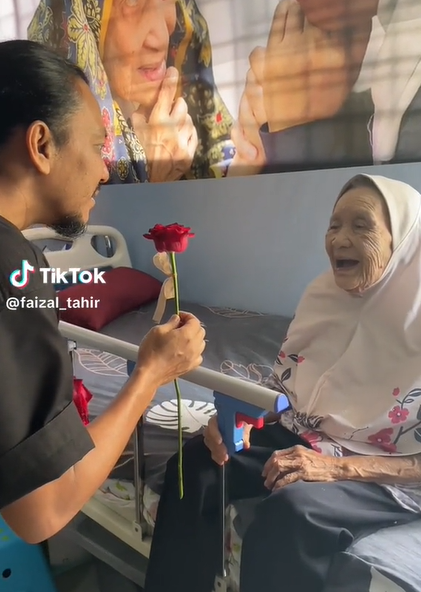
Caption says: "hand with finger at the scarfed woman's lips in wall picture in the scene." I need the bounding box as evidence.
[132,67,198,183]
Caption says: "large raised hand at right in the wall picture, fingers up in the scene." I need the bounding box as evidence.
[250,0,371,132]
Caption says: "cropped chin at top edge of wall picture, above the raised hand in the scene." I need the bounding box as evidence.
[297,0,379,31]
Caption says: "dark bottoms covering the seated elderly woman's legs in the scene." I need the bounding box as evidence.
[145,424,419,592]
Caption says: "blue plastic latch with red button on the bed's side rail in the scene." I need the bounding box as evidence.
[213,391,291,456]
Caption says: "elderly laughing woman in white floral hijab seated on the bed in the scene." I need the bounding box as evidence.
[145,175,421,592]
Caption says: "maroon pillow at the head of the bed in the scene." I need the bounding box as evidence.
[57,267,162,331]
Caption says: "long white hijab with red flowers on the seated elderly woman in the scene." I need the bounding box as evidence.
[274,175,421,455]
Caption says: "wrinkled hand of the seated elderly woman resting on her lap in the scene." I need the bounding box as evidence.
[262,446,344,491]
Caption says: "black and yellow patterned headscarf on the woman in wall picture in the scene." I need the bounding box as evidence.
[28,0,234,183]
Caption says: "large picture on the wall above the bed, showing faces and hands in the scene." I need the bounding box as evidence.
[23,0,421,183]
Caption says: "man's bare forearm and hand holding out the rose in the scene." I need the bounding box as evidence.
[1,313,205,544]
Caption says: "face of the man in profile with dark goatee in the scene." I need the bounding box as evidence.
[36,81,109,237]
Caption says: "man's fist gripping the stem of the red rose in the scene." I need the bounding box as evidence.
[137,312,206,385]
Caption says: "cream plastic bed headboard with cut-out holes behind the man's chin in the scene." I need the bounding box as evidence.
[23,225,132,271]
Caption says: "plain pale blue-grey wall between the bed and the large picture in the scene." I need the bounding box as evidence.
[91,164,421,315]
